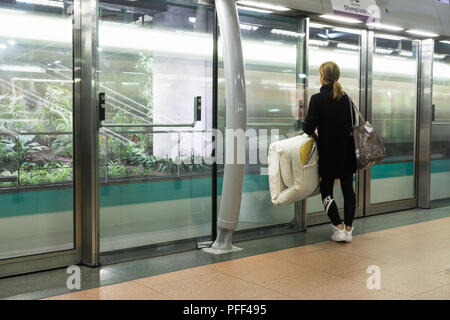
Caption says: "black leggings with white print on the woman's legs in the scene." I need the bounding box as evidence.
[320,174,356,227]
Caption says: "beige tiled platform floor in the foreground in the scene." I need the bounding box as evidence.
[44,218,450,300]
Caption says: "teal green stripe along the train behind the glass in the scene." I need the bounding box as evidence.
[0,160,450,218]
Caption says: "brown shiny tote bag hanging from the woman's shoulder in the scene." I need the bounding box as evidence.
[349,97,386,170]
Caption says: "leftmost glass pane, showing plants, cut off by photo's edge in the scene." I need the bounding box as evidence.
[0,0,74,260]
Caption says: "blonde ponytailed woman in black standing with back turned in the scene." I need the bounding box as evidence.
[304,61,356,242]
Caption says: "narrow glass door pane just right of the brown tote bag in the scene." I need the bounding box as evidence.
[368,34,419,211]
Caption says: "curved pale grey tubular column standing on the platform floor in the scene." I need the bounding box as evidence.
[207,0,247,253]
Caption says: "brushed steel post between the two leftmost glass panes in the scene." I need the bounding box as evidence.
[77,0,100,266]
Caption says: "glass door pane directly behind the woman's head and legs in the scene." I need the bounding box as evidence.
[306,22,363,224]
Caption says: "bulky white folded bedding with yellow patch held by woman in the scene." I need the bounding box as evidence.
[268,133,320,205]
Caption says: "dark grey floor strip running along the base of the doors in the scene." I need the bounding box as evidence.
[0,207,450,299]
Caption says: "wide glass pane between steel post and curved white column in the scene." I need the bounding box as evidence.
[97,1,214,253]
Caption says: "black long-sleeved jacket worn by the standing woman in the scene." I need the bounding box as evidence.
[303,84,356,179]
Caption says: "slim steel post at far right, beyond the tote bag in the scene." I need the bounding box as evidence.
[416,39,434,208]
